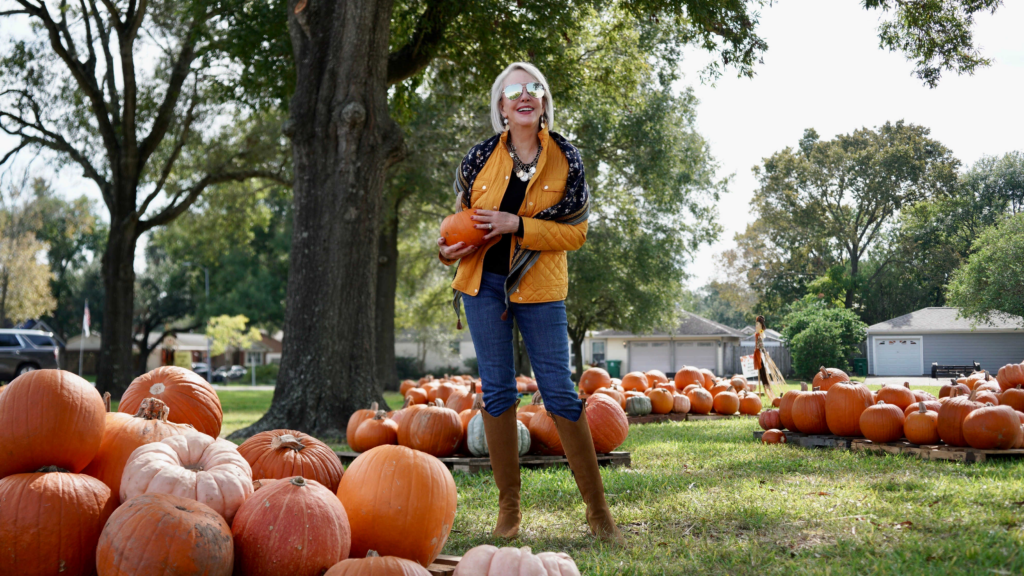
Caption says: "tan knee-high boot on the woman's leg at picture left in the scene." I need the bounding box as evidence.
[480,406,522,538]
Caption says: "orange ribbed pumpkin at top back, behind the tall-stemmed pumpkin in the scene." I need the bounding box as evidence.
[118,366,224,438]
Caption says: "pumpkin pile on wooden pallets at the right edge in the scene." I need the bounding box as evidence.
[759,364,1024,450]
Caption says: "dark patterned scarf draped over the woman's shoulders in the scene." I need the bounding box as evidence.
[452,132,590,330]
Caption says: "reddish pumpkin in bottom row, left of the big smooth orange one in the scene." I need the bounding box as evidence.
[231,475,352,576]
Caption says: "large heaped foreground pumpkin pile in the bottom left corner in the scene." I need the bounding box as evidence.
[0,367,457,576]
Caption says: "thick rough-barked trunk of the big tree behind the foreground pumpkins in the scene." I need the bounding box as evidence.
[231,0,402,439]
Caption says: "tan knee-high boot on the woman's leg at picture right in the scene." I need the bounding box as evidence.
[551,410,626,545]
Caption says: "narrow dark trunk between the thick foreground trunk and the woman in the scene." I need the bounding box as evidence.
[376,202,398,390]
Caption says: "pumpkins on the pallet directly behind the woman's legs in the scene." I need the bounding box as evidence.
[345,368,629,458]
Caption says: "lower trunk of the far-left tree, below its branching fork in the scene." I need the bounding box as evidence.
[96,224,136,399]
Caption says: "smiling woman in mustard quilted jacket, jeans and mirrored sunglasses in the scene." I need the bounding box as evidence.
[437,63,624,543]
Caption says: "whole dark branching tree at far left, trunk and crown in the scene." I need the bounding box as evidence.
[0,0,282,397]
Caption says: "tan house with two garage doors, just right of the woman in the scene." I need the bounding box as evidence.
[584,313,744,376]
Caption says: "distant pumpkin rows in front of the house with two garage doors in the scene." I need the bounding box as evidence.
[580,366,762,416]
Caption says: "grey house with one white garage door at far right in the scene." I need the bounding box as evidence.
[867,307,1024,376]
